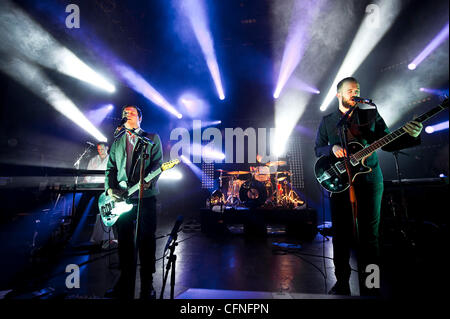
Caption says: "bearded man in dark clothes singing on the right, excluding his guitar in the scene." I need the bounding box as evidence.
[315,77,423,295]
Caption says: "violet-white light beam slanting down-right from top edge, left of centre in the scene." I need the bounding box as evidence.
[178,0,225,100]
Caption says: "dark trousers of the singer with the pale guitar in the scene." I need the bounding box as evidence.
[116,196,156,298]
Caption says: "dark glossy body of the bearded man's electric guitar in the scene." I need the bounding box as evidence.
[314,142,372,193]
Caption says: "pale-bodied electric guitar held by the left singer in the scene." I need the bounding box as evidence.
[98,159,180,227]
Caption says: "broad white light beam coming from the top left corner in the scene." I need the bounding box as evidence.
[0,0,116,93]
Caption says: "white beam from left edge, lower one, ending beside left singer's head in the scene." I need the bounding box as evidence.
[0,59,107,142]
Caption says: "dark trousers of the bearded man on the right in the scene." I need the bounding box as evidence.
[330,181,384,291]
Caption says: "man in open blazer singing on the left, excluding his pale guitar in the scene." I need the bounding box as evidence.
[105,105,163,299]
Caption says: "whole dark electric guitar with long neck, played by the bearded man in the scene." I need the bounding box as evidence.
[314,98,448,193]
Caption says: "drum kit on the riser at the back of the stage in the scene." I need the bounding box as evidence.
[207,161,305,208]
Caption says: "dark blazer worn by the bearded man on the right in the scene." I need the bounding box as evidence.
[314,108,420,183]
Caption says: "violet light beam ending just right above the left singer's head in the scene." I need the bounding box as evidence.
[115,64,183,119]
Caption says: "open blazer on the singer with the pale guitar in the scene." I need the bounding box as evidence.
[105,131,163,197]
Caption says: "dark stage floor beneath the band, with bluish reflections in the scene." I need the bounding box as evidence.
[0,206,442,299]
